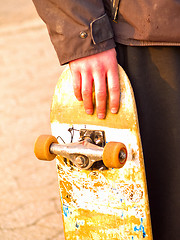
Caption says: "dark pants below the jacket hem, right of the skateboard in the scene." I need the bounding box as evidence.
[117,44,180,240]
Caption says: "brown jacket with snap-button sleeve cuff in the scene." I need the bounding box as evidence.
[33,0,180,64]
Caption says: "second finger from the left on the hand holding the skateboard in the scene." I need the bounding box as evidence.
[81,72,93,114]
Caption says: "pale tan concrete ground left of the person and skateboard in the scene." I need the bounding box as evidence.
[0,0,64,240]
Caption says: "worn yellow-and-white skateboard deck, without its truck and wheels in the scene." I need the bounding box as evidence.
[51,64,152,240]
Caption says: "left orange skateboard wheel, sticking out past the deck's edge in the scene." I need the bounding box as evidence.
[34,135,58,161]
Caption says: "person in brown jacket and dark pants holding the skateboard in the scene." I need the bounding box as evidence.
[33,0,180,240]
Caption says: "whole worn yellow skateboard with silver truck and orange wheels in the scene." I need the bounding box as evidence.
[34,66,153,240]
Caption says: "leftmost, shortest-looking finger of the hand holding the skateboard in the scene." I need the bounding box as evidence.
[71,71,83,101]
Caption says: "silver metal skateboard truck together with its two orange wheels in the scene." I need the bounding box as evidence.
[34,129,127,169]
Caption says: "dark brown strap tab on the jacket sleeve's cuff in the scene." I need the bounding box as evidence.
[90,14,113,44]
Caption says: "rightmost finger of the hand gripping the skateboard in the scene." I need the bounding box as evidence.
[107,65,120,113]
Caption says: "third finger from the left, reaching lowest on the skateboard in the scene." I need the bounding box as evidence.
[93,70,107,119]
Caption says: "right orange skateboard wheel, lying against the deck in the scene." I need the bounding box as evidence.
[103,142,127,168]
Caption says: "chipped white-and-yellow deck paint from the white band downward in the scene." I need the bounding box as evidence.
[52,122,152,240]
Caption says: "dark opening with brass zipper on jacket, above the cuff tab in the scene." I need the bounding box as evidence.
[103,0,120,20]
